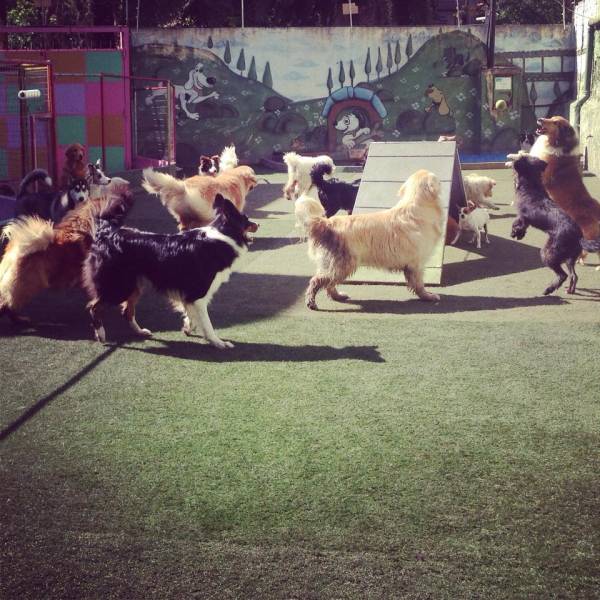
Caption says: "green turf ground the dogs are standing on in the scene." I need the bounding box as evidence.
[0,170,600,600]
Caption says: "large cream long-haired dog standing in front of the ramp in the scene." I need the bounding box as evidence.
[295,169,443,310]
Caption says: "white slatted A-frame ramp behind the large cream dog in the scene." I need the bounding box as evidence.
[352,142,466,285]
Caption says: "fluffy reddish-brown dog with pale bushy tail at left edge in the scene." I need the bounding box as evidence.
[0,178,133,322]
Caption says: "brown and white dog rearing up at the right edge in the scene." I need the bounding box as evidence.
[530,116,600,248]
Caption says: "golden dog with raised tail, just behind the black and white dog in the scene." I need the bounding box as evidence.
[142,166,257,231]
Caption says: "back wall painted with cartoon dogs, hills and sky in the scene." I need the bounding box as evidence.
[131,26,575,165]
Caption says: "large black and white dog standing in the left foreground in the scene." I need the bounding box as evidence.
[83,194,258,349]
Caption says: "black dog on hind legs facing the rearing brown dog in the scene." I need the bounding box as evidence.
[511,155,583,295]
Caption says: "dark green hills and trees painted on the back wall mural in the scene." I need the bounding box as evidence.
[133,30,520,167]
